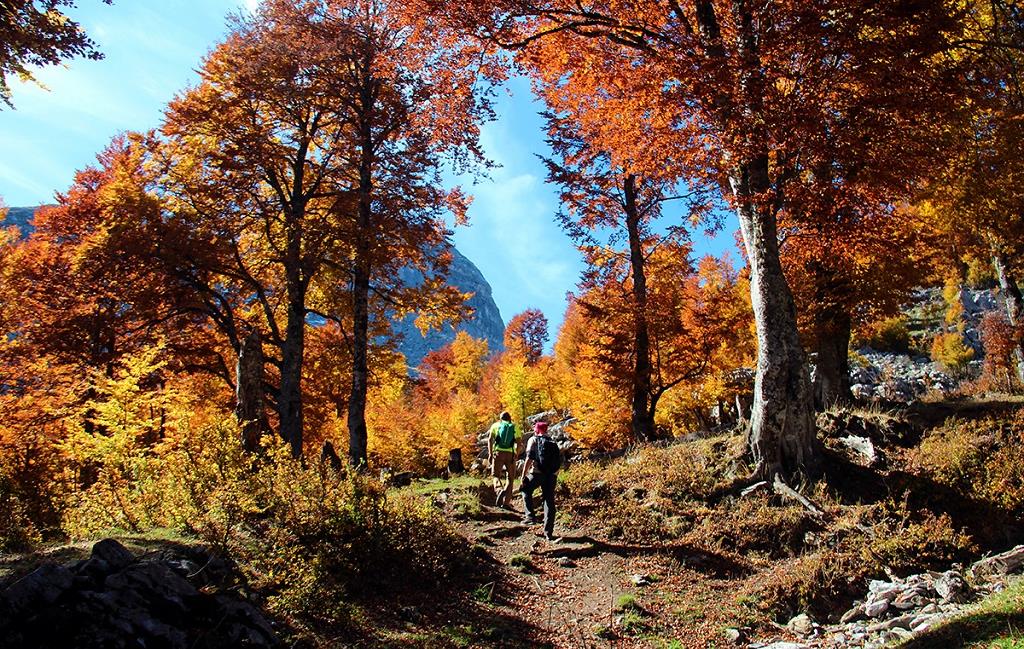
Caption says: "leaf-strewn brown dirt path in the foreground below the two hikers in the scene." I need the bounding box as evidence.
[459,499,770,649]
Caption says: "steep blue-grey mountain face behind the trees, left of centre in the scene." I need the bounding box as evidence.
[394,248,505,367]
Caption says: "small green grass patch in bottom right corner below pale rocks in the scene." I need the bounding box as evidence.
[893,579,1024,649]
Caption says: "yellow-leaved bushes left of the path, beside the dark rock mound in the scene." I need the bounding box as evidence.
[57,422,473,634]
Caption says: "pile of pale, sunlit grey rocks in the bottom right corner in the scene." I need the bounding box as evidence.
[749,546,1024,649]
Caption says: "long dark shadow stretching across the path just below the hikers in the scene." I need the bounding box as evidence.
[539,535,754,579]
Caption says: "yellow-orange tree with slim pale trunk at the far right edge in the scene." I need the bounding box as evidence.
[915,0,1024,381]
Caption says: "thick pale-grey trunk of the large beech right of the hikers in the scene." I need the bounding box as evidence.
[729,155,820,479]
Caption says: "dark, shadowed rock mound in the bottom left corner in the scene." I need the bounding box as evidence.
[0,538,281,649]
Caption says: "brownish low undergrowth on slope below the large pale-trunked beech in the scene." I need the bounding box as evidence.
[562,407,1024,622]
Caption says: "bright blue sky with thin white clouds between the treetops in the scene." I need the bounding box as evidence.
[0,0,735,338]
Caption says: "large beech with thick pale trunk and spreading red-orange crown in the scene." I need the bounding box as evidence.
[424,0,958,477]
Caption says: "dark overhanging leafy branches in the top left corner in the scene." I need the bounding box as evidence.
[0,0,112,106]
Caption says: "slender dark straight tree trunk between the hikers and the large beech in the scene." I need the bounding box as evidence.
[624,175,654,441]
